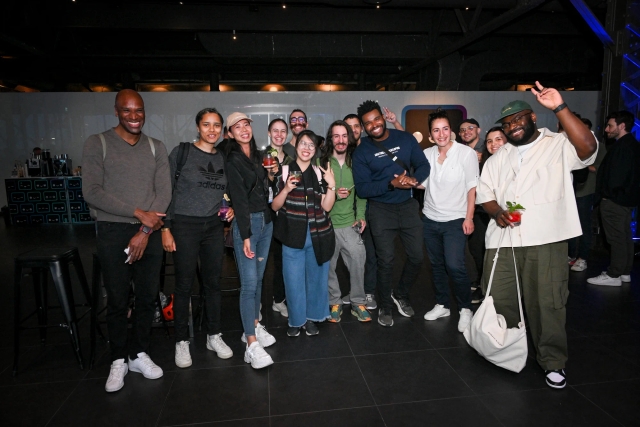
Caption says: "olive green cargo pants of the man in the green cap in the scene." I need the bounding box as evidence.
[482,242,569,370]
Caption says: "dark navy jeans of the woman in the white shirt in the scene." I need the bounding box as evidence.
[422,216,471,310]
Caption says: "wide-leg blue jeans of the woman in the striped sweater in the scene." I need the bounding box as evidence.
[282,227,329,328]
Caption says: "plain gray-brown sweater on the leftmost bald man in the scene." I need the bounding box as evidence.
[82,128,171,222]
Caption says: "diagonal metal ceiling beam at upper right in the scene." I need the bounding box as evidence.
[389,0,546,83]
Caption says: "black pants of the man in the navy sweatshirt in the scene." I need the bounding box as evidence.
[369,199,424,309]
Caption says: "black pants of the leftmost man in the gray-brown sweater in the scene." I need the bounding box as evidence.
[97,221,163,361]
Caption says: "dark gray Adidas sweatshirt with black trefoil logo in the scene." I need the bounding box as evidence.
[164,144,227,228]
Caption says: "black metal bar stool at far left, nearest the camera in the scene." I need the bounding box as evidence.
[13,247,95,375]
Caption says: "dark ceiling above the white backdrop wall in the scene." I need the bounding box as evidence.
[0,0,607,91]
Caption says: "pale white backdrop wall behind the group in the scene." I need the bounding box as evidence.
[0,92,599,205]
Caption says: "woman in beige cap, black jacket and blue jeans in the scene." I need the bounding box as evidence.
[227,112,276,369]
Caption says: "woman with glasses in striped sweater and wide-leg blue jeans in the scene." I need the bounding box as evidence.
[271,130,336,337]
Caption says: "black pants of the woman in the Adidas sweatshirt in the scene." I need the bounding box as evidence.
[171,215,224,342]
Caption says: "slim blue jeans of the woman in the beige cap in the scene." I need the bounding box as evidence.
[232,212,273,336]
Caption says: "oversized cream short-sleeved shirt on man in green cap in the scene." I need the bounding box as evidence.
[476,128,598,248]
